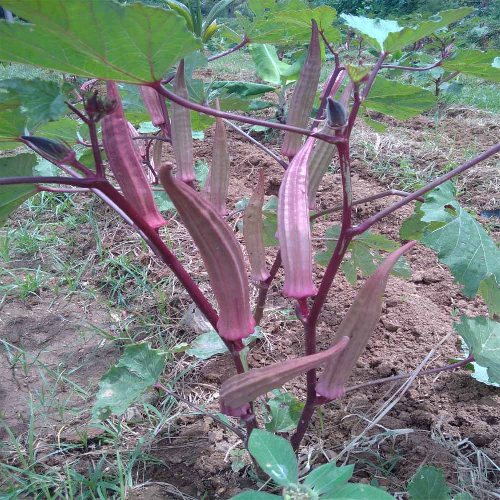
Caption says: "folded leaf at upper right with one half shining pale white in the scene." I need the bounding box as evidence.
[340,8,474,52]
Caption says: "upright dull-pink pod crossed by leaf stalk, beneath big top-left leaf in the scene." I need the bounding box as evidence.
[171,59,196,182]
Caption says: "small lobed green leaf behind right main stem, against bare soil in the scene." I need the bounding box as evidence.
[314,226,410,286]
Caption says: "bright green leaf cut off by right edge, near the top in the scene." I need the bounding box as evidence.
[441,49,500,82]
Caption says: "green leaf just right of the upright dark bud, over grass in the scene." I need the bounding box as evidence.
[363,76,437,120]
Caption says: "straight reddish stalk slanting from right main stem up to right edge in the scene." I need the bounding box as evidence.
[349,143,500,237]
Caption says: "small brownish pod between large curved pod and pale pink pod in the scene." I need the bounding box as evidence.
[243,169,269,281]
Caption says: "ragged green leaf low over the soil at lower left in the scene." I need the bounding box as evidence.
[92,343,165,420]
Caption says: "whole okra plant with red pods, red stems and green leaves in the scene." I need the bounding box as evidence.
[0,0,500,498]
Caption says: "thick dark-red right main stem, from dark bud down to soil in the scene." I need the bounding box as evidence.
[290,143,352,451]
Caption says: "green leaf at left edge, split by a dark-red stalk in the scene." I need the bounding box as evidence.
[0,153,38,227]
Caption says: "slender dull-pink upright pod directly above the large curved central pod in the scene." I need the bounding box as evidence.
[209,99,230,215]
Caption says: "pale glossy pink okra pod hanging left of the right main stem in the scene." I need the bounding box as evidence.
[278,133,316,299]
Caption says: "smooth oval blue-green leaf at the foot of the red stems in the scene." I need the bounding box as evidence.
[248,429,299,486]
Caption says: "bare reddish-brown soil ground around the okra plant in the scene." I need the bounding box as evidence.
[0,107,500,499]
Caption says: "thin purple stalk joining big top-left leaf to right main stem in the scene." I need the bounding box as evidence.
[151,82,345,143]
